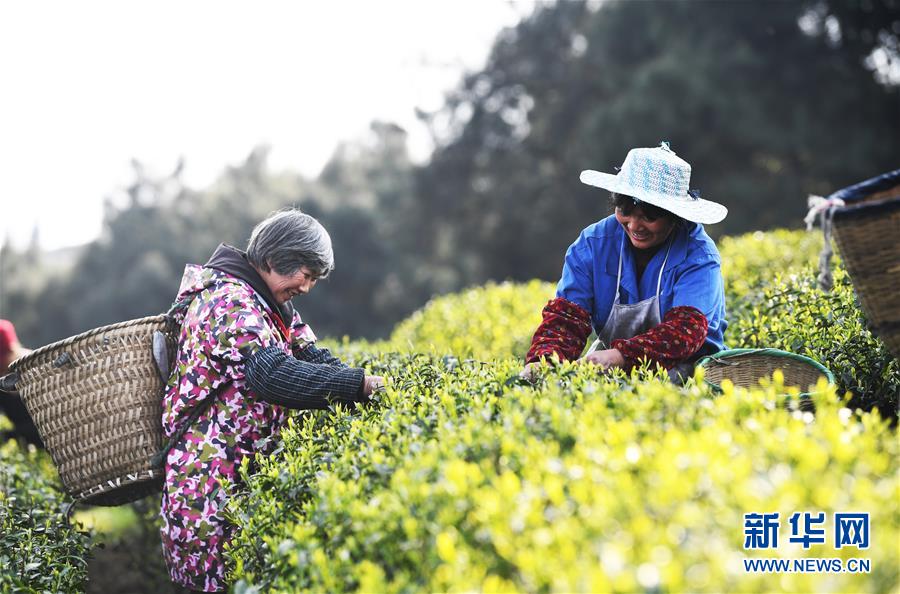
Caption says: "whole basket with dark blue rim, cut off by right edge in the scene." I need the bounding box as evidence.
[833,175,900,359]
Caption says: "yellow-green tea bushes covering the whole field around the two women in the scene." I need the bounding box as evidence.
[0,231,900,592]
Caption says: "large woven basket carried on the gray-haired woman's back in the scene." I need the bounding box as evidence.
[11,315,177,505]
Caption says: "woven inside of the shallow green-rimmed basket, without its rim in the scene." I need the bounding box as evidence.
[703,353,824,392]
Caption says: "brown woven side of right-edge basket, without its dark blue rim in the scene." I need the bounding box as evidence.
[834,186,900,359]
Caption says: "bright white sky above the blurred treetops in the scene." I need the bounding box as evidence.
[0,0,532,249]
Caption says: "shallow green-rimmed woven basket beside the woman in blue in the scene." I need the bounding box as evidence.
[697,349,834,396]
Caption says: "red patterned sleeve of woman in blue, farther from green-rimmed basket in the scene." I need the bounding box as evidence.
[525,297,591,364]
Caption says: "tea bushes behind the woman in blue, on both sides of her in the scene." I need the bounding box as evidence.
[378,229,900,417]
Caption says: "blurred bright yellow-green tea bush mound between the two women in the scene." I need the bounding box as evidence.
[390,280,556,360]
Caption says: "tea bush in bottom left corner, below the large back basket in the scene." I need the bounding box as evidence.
[0,430,90,593]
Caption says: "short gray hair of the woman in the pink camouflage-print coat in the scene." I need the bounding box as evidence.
[247,208,334,278]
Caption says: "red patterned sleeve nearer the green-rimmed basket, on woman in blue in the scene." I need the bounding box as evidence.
[610,306,709,369]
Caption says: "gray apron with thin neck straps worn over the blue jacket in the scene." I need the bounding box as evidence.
[586,237,694,383]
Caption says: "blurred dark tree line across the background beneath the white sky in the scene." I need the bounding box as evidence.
[0,0,900,347]
